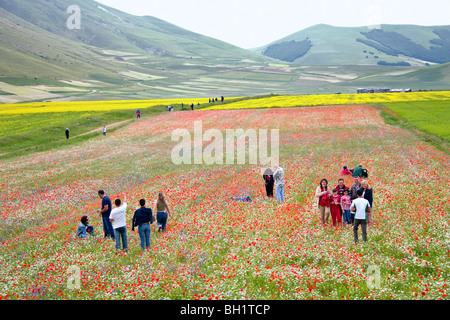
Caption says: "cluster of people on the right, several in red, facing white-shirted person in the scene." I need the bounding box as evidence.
[315,166,373,243]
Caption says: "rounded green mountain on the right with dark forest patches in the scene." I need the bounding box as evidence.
[257,24,450,66]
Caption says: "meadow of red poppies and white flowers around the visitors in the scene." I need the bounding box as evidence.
[0,104,450,300]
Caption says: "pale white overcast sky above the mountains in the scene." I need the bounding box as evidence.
[96,0,450,49]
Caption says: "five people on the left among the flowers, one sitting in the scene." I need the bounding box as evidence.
[76,190,170,251]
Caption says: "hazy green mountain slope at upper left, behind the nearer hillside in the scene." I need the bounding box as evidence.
[0,0,267,61]
